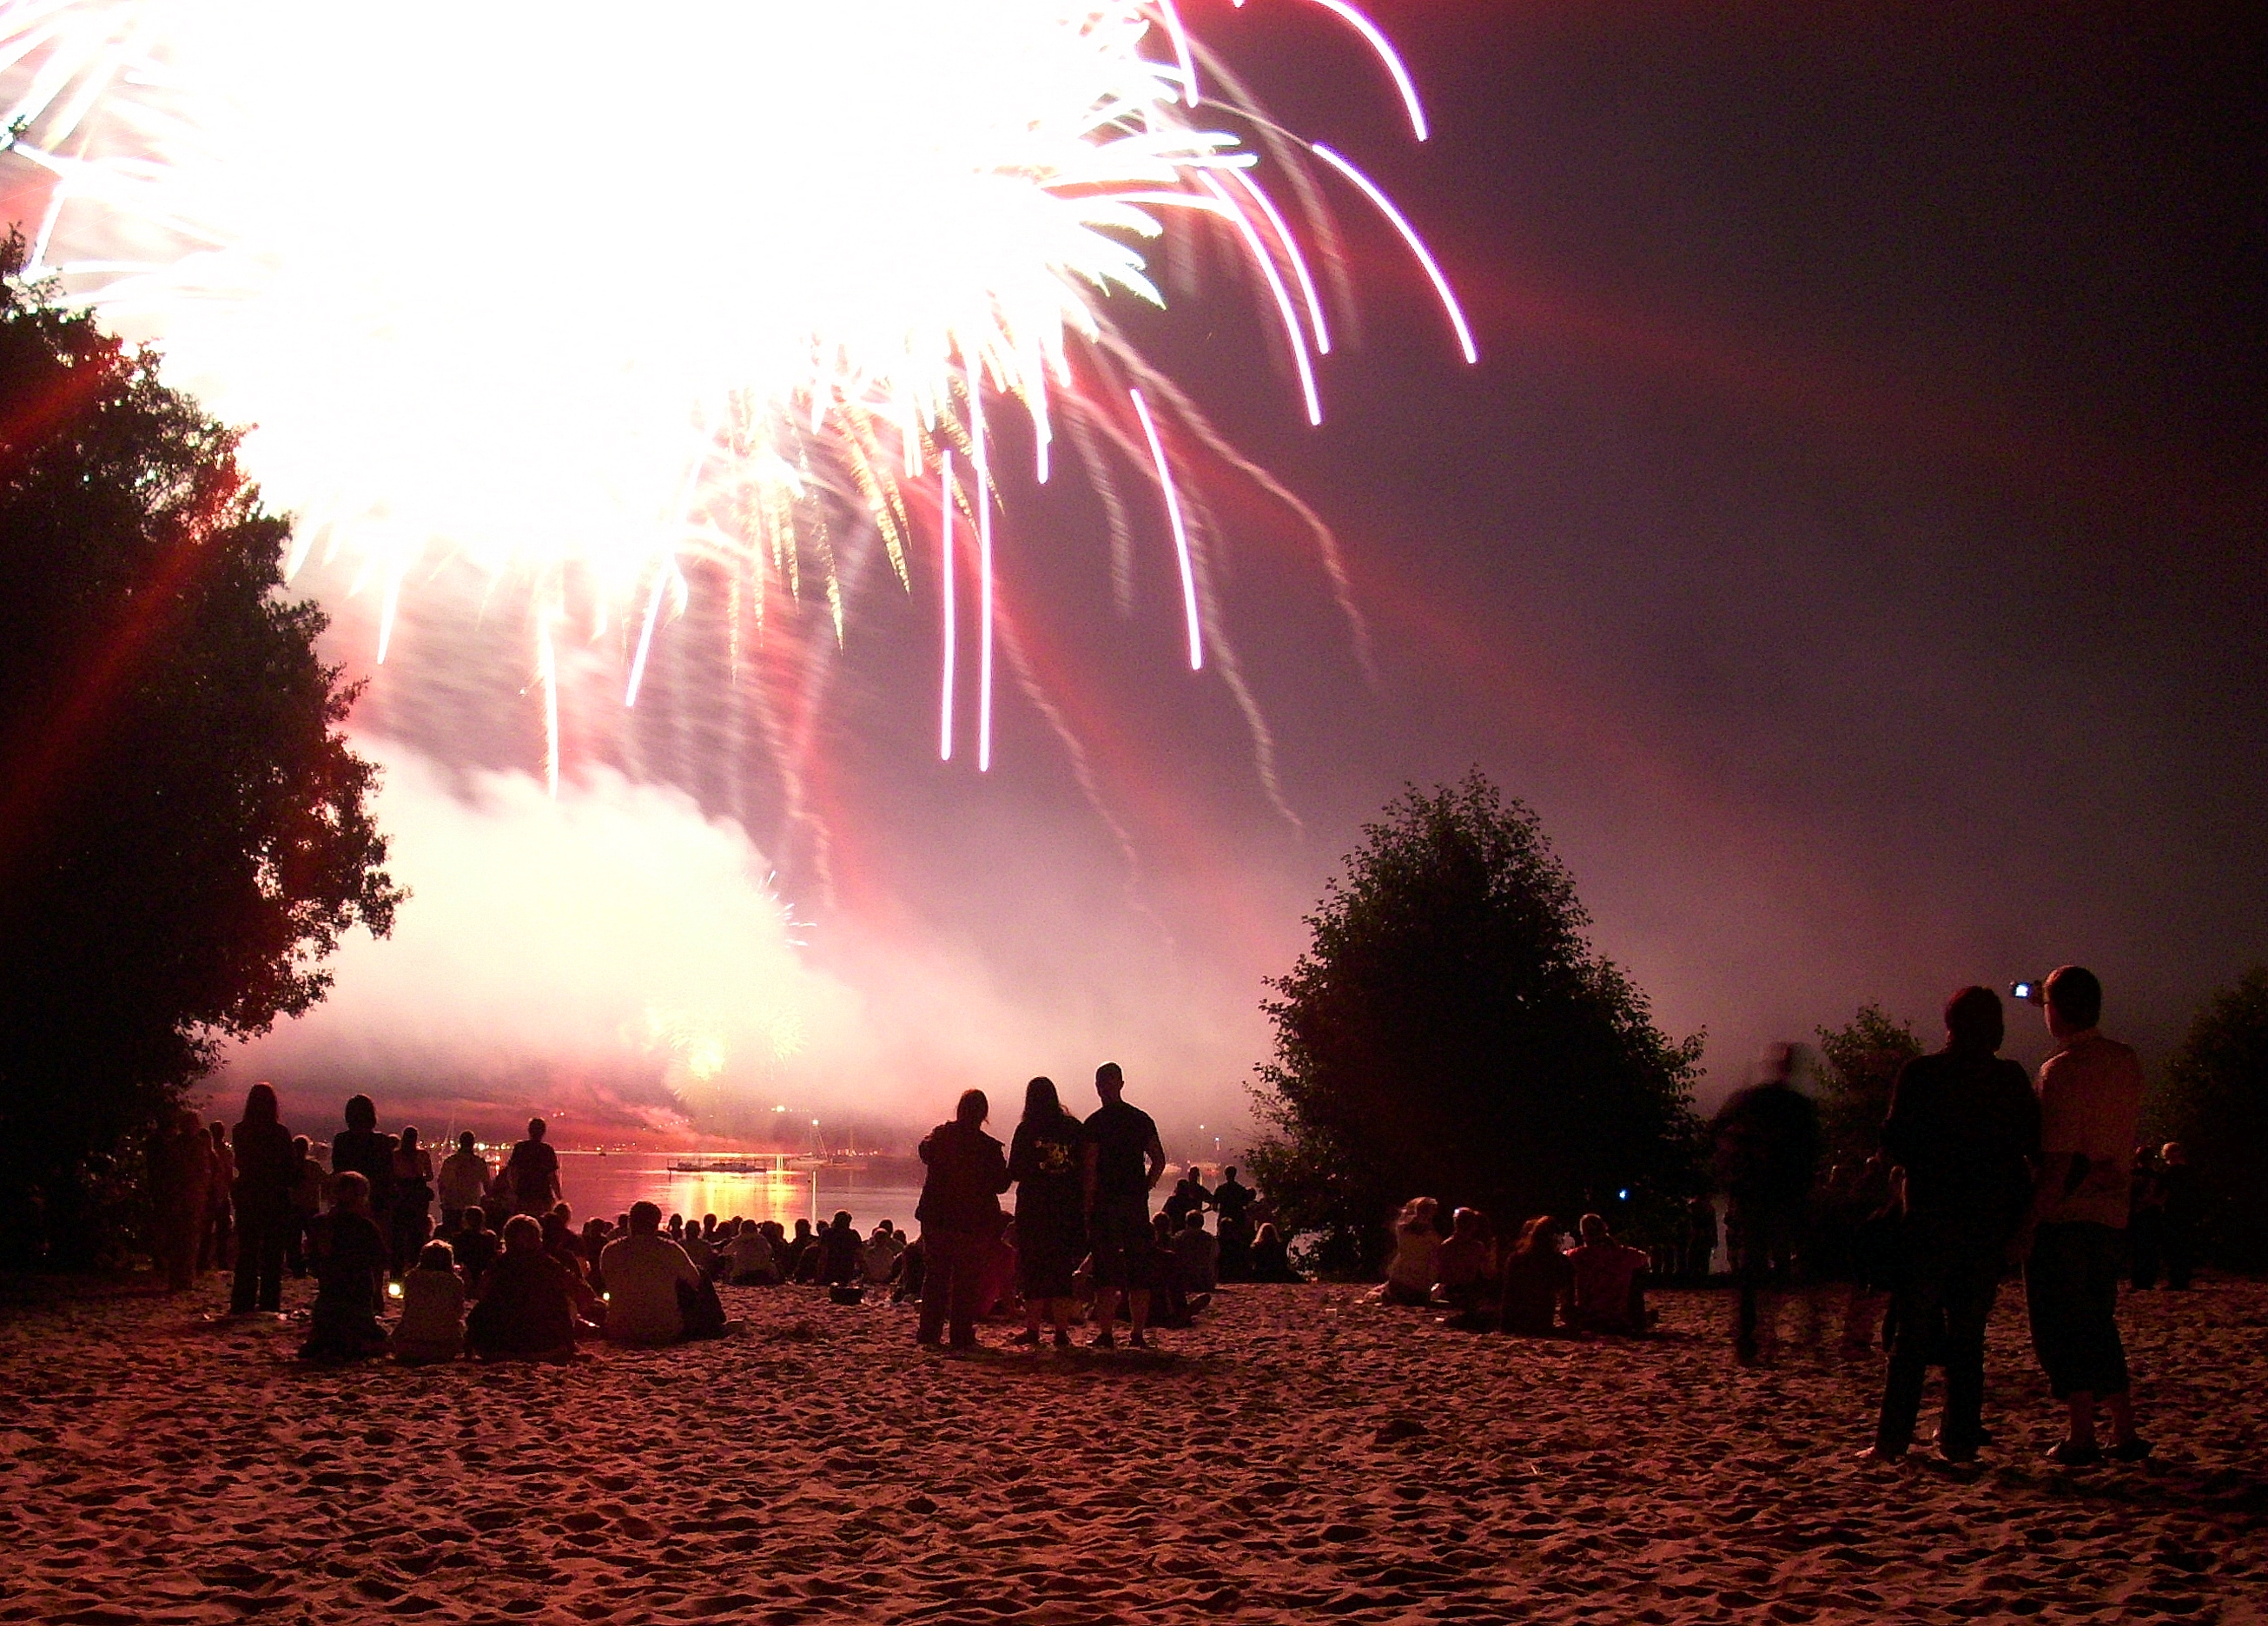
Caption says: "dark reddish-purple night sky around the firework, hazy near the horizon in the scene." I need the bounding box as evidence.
[88,0,2268,1134]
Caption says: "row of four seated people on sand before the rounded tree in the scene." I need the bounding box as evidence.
[1379,1198,1656,1338]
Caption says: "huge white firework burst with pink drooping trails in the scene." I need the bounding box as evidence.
[0,0,1477,790]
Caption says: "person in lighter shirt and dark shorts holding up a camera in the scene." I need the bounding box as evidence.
[2023,966,2150,1467]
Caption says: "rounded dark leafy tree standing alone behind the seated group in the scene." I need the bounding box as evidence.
[1250,771,1701,1267]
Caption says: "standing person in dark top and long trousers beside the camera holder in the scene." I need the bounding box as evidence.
[1864,988,2039,1463]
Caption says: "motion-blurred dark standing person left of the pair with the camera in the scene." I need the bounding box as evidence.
[1710,1046,1819,1365]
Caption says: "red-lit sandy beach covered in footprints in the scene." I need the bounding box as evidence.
[0,1279,2268,1626]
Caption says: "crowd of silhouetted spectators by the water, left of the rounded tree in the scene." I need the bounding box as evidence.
[149,1066,1299,1363]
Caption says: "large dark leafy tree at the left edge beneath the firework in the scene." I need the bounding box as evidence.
[0,236,401,1263]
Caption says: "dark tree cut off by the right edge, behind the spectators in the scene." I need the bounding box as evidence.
[2150,966,2268,1270]
